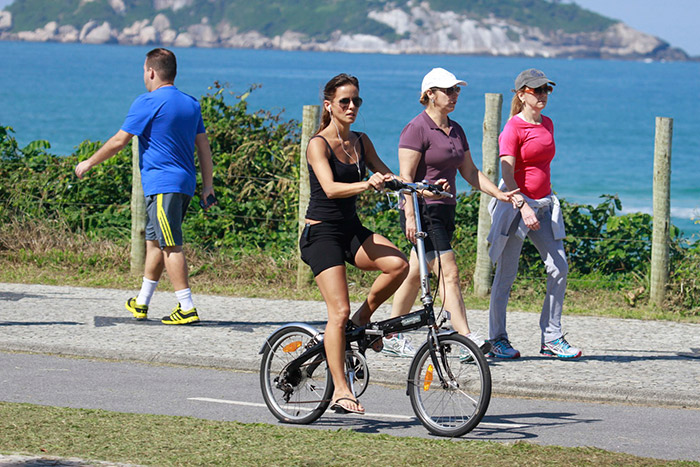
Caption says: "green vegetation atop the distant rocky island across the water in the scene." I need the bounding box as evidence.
[8,0,614,41]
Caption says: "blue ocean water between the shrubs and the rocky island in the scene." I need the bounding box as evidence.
[0,42,700,236]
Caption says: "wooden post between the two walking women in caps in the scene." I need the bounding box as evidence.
[474,93,503,297]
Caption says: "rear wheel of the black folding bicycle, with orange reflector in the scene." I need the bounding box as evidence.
[260,326,333,424]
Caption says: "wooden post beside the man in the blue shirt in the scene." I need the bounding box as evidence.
[131,136,146,275]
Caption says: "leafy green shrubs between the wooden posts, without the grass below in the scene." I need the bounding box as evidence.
[0,83,700,314]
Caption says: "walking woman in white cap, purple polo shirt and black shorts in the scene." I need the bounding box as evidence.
[384,68,515,356]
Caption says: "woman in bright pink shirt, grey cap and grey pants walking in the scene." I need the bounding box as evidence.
[488,68,581,358]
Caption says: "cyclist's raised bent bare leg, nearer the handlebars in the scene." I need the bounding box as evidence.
[353,234,409,324]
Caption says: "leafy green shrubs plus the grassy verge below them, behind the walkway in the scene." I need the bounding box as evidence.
[0,83,700,316]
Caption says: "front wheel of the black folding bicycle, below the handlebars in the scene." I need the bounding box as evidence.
[408,334,491,437]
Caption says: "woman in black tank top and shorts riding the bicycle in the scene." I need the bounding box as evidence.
[299,73,408,413]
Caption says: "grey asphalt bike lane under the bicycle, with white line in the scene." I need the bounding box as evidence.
[5,352,700,464]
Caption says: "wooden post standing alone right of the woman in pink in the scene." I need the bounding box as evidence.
[649,117,673,306]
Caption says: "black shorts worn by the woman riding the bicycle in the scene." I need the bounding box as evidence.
[299,217,373,277]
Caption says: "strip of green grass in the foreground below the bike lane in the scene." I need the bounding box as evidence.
[0,402,698,466]
